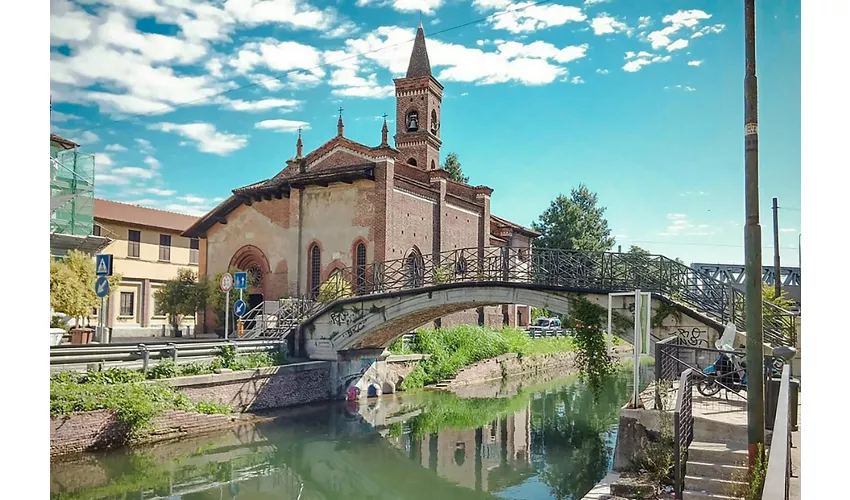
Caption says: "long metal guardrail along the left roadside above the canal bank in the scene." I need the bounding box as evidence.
[50,339,286,370]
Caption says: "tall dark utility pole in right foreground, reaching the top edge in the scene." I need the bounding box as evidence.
[744,0,764,472]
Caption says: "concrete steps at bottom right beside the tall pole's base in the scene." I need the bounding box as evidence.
[682,440,747,500]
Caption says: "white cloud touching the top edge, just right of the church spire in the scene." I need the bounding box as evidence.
[472,0,587,33]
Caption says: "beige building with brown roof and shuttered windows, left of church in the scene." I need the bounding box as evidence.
[94,199,201,340]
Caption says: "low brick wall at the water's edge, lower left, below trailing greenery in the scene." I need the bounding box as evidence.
[50,410,231,457]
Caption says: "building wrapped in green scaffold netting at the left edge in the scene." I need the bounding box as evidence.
[50,134,109,257]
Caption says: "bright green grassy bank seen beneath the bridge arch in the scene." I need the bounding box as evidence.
[390,325,575,390]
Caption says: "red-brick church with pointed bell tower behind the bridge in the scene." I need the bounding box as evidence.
[189,23,539,331]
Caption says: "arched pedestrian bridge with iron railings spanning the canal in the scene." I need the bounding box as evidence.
[276,247,799,360]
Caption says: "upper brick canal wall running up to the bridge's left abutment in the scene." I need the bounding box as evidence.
[169,361,330,411]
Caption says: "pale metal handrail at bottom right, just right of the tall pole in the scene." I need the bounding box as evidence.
[761,364,791,500]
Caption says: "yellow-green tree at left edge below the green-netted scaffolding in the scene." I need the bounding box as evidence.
[50,250,121,326]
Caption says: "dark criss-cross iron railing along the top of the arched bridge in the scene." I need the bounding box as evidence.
[311,247,799,346]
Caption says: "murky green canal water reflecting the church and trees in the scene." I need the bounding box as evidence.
[50,366,651,500]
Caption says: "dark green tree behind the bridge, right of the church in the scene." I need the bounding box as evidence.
[532,184,614,252]
